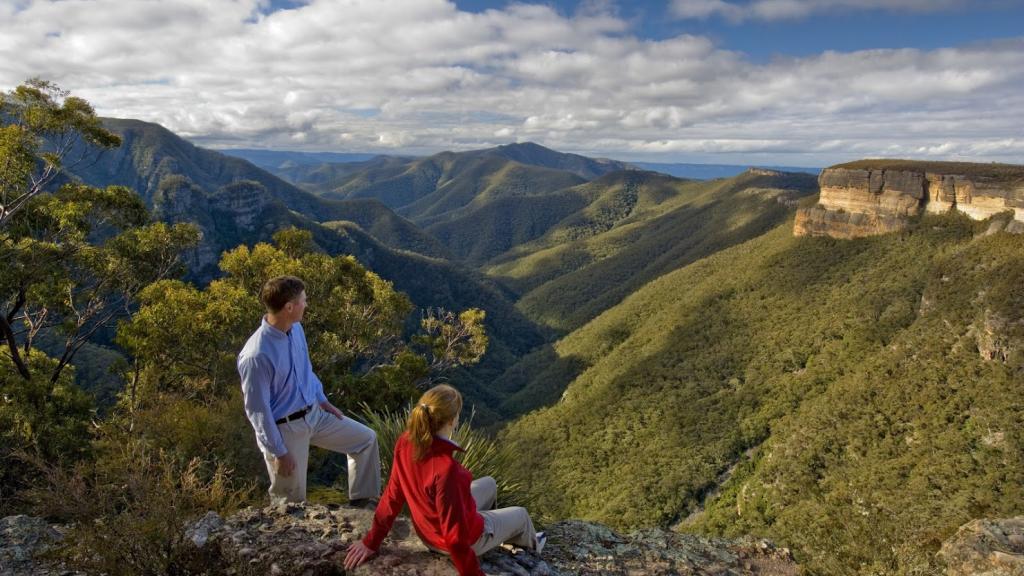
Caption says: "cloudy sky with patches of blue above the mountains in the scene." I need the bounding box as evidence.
[0,0,1024,166]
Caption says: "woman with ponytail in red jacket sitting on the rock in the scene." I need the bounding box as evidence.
[345,384,545,576]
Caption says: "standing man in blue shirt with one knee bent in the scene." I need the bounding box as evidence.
[238,276,381,507]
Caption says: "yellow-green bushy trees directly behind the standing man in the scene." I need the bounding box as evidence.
[118,229,486,496]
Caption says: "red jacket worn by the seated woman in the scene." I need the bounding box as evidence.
[362,433,483,576]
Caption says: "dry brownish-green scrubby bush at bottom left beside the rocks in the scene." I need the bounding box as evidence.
[26,439,253,576]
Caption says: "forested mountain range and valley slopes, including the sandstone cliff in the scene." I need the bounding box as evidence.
[54,120,1024,575]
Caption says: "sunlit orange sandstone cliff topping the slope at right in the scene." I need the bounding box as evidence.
[794,160,1024,238]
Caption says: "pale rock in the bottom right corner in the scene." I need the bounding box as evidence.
[938,517,1024,576]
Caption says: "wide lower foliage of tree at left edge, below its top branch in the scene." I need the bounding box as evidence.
[0,184,198,381]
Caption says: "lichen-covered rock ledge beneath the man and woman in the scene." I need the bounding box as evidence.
[0,504,800,576]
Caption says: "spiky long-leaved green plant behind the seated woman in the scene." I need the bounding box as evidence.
[360,406,528,506]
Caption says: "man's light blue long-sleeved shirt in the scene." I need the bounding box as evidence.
[238,317,327,456]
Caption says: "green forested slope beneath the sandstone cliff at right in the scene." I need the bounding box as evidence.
[503,215,1024,574]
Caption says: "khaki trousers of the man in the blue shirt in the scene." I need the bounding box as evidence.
[263,405,381,503]
